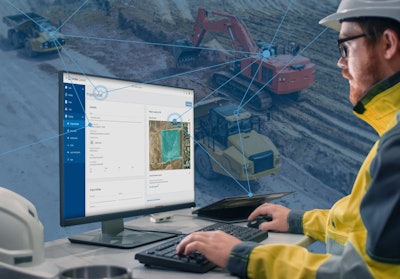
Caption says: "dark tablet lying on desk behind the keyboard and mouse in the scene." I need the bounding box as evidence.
[192,192,293,223]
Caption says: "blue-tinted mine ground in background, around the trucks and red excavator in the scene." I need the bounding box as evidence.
[0,0,377,241]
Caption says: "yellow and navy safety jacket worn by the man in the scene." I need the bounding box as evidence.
[227,72,400,279]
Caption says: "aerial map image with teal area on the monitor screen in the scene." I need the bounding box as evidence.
[149,121,190,171]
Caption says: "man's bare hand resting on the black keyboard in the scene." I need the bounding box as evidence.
[176,231,242,267]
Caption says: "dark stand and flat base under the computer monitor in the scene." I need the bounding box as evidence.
[68,219,178,249]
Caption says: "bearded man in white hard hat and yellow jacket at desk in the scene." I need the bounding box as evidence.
[177,0,400,279]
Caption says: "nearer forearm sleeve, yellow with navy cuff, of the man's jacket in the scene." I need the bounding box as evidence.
[227,240,392,279]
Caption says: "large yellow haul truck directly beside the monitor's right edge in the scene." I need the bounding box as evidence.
[194,97,281,181]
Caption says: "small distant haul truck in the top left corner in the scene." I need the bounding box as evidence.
[3,13,65,57]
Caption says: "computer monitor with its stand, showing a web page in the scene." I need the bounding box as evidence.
[59,71,195,248]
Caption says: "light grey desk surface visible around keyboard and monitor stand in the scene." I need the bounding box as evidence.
[45,209,304,279]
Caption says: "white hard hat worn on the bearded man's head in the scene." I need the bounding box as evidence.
[319,0,400,31]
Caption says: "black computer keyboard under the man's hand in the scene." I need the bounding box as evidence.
[135,223,268,273]
